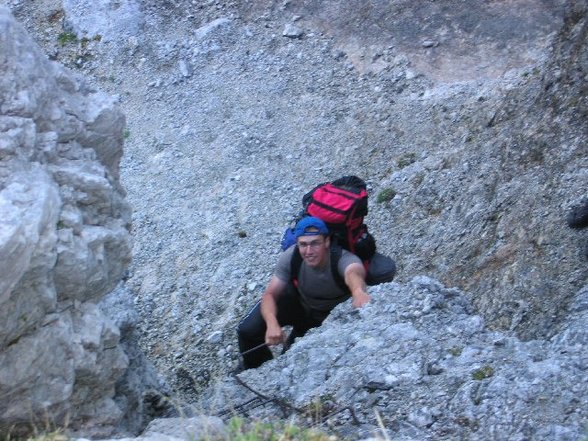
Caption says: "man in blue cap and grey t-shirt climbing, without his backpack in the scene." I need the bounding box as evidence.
[237,216,370,369]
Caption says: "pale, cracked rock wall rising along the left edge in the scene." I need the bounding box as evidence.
[0,7,131,435]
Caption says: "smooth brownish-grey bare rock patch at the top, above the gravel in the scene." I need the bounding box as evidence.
[241,0,564,84]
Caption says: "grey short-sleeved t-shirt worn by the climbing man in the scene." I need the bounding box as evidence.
[274,245,361,312]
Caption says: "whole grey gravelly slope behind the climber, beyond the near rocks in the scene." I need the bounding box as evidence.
[8,0,588,439]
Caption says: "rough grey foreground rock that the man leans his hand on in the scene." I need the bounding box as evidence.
[202,277,588,441]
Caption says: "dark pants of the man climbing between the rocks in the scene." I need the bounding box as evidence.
[237,284,329,369]
